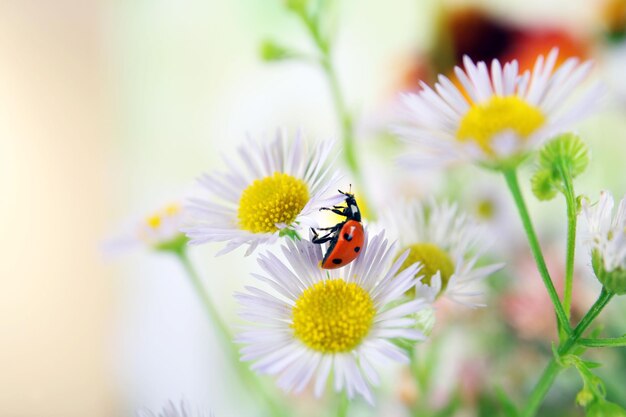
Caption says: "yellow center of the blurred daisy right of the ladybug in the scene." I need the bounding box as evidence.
[400,243,454,291]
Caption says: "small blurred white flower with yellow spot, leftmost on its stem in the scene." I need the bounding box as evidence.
[105,203,187,252]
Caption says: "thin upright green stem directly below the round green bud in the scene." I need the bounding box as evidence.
[559,165,577,320]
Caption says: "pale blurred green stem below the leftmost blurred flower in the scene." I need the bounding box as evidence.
[173,247,286,417]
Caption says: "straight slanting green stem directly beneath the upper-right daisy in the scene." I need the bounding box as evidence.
[502,169,571,333]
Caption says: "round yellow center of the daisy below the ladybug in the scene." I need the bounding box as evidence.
[291,279,376,353]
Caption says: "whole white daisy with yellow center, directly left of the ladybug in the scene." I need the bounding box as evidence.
[184,132,342,255]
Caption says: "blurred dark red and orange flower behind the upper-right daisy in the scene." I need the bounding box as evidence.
[400,5,588,91]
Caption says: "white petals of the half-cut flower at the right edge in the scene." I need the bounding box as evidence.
[582,191,626,272]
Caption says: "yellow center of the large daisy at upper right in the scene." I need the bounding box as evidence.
[456,96,546,154]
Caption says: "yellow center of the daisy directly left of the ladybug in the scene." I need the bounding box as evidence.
[237,172,309,233]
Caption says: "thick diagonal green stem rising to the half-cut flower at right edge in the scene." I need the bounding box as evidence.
[522,288,614,417]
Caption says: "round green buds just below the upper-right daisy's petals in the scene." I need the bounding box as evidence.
[531,133,589,200]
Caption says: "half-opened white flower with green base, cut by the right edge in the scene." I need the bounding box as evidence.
[582,191,626,294]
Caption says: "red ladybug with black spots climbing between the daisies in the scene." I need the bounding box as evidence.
[311,190,365,269]
